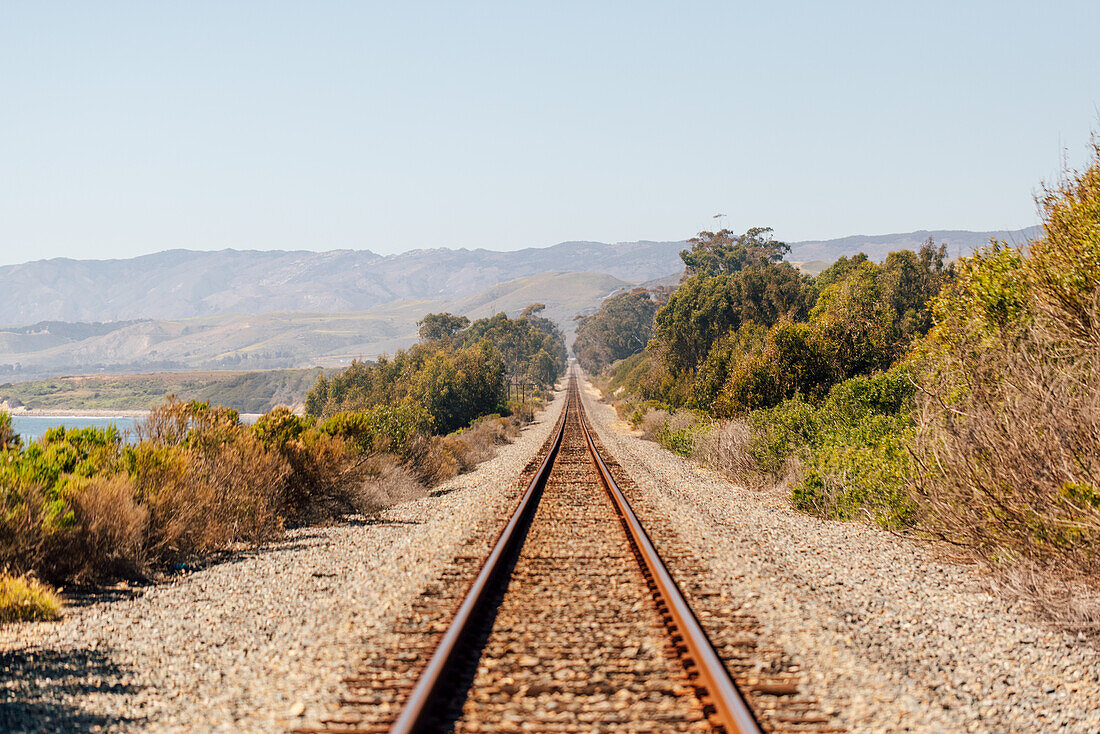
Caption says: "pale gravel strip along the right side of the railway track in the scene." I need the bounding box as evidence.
[584,385,1100,732]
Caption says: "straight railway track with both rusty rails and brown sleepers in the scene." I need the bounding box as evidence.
[298,377,836,733]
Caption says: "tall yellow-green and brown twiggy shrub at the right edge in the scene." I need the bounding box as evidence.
[916,144,1100,629]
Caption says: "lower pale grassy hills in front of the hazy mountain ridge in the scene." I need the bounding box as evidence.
[0,273,630,383]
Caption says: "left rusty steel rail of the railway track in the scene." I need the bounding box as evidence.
[389,399,575,734]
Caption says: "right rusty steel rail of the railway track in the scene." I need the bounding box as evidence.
[578,387,761,734]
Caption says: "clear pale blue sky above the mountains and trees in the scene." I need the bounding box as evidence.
[0,0,1100,263]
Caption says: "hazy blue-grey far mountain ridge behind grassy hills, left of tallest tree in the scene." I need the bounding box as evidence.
[0,242,683,325]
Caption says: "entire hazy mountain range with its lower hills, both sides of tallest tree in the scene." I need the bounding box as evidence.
[0,228,1037,381]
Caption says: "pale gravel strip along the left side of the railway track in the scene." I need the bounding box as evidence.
[0,391,565,732]
